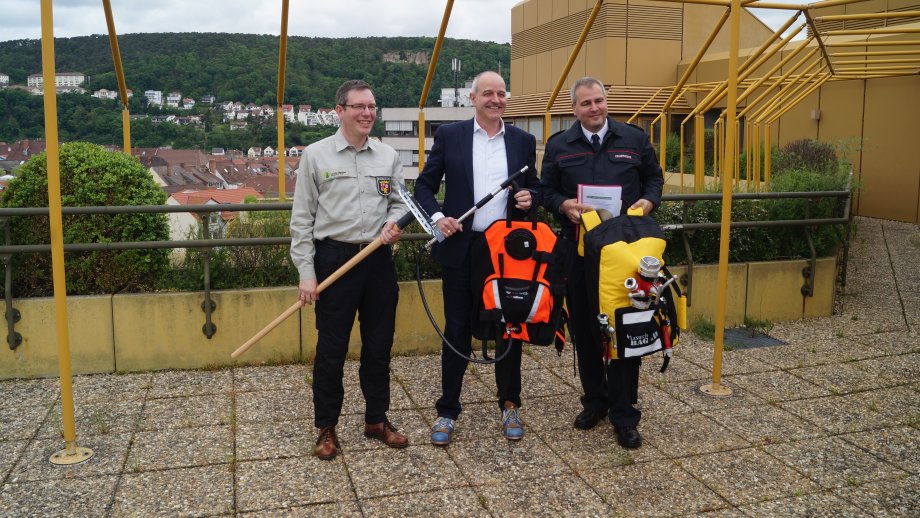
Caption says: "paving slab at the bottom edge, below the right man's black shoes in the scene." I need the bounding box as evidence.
[584,461,729,516]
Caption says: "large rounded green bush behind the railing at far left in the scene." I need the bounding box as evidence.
[2,142,169,297]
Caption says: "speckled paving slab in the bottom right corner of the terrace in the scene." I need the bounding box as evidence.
[833,476,920,518]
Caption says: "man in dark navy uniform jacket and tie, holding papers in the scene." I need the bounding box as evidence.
[542,77,664,448]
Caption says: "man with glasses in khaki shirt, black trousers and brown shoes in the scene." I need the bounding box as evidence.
[291,80,409,460]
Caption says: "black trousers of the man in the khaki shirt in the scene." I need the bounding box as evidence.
[313,240,399,428]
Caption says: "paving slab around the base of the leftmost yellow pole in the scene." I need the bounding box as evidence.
[7,434,131,483]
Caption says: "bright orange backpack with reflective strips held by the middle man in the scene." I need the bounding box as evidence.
[471,211,565,351]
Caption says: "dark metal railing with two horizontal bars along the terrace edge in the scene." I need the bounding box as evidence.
[0,190,851,349]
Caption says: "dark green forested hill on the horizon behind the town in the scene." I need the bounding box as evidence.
[0,33,511,106]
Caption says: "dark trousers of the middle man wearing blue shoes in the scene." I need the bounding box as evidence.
[435,242,521,419]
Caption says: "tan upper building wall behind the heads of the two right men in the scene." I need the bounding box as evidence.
[510,0,772,95]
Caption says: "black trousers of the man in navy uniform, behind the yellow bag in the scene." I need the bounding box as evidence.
[565,239,642,427]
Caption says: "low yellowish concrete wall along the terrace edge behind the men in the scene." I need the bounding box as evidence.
[0,258,836,379]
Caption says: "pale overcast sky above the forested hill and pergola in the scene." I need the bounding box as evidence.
[0,0,798,43]
